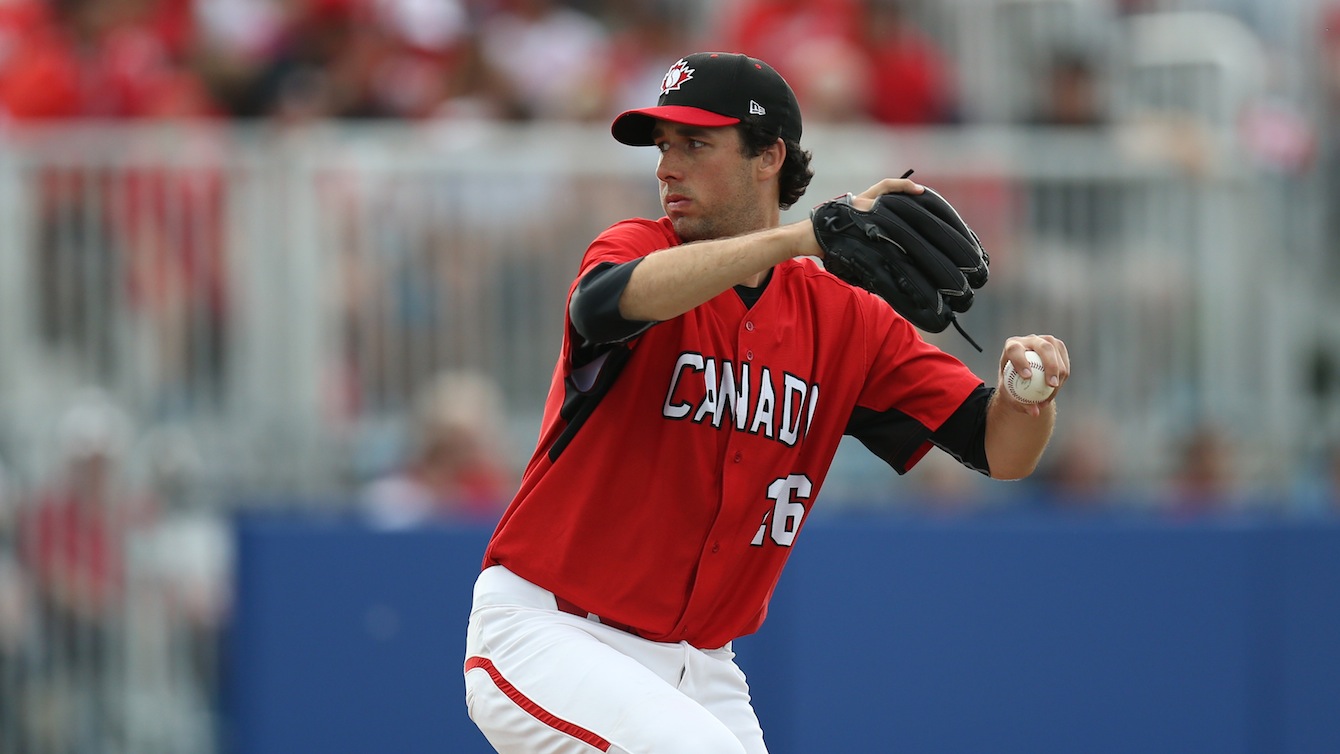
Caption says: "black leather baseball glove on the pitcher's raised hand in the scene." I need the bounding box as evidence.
[809,175,990,351]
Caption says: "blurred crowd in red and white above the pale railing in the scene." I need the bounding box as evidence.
[0,0,1318,125]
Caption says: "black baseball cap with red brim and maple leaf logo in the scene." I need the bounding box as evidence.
[610,52,800,146]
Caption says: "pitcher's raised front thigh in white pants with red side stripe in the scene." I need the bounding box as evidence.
[465,583,746,754]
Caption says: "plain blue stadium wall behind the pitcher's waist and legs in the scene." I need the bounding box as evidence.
[224,514,1340,754]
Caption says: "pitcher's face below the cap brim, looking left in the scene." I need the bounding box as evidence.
[653,121,769,242]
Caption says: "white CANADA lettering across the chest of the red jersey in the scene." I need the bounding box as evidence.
[661,351,819,446]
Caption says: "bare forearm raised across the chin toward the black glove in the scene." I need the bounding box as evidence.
[619,220,819,321]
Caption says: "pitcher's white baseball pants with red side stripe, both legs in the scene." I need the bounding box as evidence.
[465,565,766,754]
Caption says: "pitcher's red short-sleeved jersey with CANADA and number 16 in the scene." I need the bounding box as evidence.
[484,218,982,648]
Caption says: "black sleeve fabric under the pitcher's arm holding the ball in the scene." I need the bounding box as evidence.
[846,386,994,474]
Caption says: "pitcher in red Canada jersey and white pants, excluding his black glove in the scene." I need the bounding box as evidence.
[465,52,1069,754]
